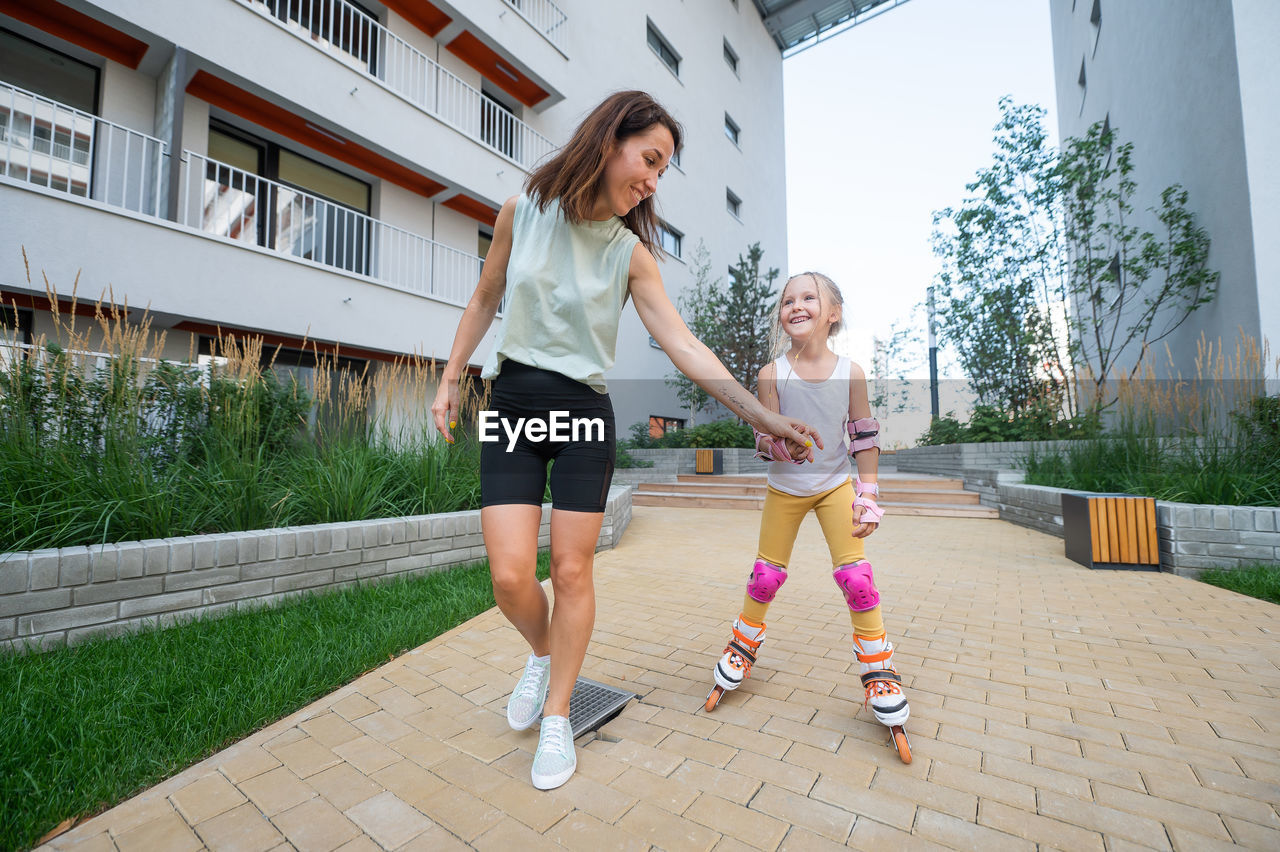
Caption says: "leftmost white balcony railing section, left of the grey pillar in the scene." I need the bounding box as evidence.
[0,81,168,216]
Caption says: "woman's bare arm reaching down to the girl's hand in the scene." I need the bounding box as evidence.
[628,240,823,446]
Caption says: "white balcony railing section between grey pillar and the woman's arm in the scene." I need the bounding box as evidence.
[186,151,481,306]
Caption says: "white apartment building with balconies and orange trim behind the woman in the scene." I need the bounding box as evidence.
[0,0,793,434]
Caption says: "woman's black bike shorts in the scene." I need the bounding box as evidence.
[479,359,616,512]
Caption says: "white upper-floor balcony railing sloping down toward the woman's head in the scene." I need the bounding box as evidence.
[236,0,554,171]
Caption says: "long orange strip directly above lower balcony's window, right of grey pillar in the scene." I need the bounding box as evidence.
[187,70,444,197]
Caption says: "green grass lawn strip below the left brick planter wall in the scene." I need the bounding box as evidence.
[0,554,548,849]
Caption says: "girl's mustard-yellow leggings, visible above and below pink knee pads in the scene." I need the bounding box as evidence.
[742,480,884,637]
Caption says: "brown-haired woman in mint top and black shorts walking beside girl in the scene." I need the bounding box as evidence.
[431,92,822,789]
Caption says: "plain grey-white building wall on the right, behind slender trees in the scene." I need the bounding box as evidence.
[1050,0,1280,376]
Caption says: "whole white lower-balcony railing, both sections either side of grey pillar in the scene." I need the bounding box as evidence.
[0,82,483,314]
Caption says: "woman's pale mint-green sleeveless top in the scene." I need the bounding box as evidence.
[481,194,640,394]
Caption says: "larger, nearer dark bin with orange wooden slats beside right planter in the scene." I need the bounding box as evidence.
[1062,494,1160,571]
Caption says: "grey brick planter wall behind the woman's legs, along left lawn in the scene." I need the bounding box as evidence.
[0,486,631,650]
